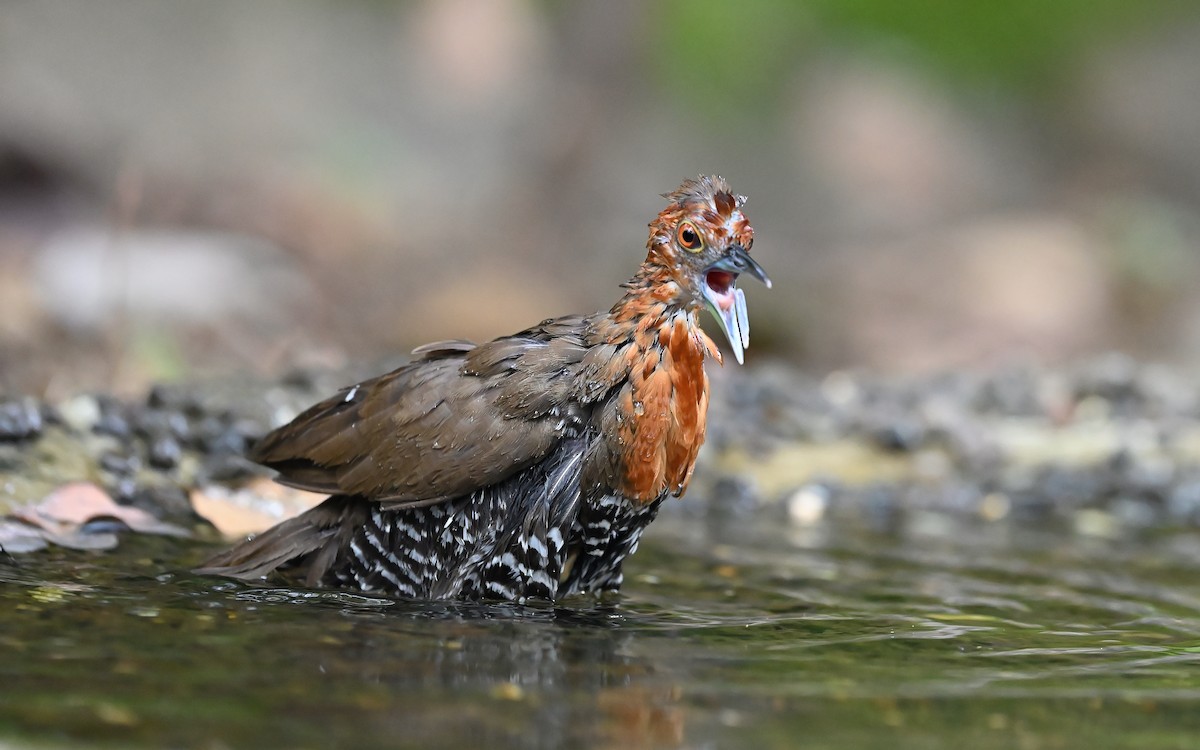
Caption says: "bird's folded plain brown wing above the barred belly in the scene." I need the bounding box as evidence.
[251,318,597,506]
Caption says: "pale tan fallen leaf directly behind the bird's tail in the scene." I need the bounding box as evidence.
[191,478,326,536]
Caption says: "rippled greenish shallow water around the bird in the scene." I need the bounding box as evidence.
[0,516,1200,749]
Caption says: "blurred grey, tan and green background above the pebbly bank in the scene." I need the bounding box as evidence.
[0,0,1200,396]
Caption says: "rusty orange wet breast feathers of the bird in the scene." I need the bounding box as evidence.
[618,314,716,503]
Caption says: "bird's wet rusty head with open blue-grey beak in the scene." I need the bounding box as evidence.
[646,176,770,364]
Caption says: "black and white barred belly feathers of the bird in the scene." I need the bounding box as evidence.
[211,437,661,602]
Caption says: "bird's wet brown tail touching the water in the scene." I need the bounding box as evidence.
[192,494,368,587]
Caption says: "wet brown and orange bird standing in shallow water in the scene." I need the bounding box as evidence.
[197,175,770,604]
